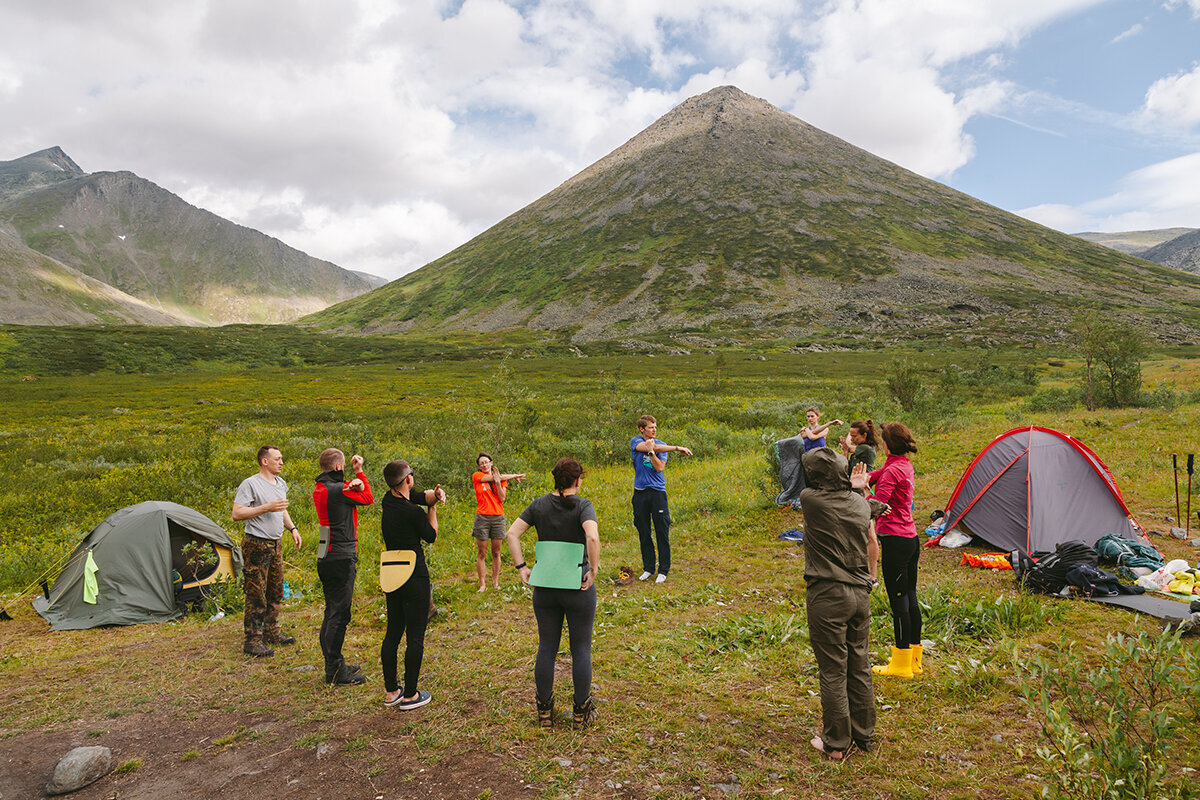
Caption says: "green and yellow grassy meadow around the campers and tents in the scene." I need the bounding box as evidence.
[0,345,1200,799]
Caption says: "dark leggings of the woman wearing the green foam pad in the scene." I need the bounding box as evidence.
[533,585,596,705]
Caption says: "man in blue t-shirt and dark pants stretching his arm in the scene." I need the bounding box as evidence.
[629,414,691,583]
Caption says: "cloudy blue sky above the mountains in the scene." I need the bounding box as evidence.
[0,0,1200,277]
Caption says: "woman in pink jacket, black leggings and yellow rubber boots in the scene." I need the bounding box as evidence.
[870,422,922,678]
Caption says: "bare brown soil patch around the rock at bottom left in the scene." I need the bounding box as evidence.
[0,711,535,800]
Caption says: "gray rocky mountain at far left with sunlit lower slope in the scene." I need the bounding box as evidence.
[0,148,379,325]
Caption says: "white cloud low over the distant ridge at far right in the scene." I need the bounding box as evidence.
[1018,152,1200,233]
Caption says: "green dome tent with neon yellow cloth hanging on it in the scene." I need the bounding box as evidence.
[34,500,242,631]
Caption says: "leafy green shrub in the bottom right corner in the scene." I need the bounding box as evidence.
[1021,633,1200,800]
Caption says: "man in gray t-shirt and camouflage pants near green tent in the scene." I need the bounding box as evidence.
[233,445,301,658]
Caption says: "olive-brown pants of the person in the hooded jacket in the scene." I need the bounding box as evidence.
[804,581,875,750]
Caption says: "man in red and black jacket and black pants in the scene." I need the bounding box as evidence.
[312,447,374,686]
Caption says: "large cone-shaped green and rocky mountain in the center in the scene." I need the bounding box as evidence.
[305,86,1200,344]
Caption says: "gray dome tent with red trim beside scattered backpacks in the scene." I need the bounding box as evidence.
[944,426,1139,553]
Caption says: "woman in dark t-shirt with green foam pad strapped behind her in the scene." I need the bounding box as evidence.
[506,458,600,729]
